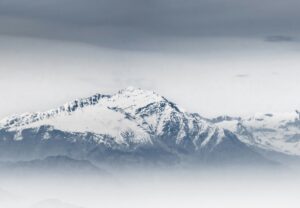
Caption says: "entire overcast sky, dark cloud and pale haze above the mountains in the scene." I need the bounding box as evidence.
[0,0,300,117]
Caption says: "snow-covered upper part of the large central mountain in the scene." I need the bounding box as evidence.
[0,87,222,149]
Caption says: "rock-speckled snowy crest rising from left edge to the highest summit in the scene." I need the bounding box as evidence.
[0,87,175,131]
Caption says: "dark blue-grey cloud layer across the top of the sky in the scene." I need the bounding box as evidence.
[0,0,300,48]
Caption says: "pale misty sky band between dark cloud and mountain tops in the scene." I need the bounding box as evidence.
[0,37,300,118]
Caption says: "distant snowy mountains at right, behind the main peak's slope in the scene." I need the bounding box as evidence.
[211,111,300,155]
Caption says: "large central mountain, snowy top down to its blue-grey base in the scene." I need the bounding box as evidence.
[0,87,264,167]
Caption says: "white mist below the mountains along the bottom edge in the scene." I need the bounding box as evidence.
[0,169,300,208]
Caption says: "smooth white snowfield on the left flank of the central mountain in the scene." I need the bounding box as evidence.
[0,88,155,145]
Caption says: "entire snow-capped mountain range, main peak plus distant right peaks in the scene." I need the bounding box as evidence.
[0,87,300,170]
